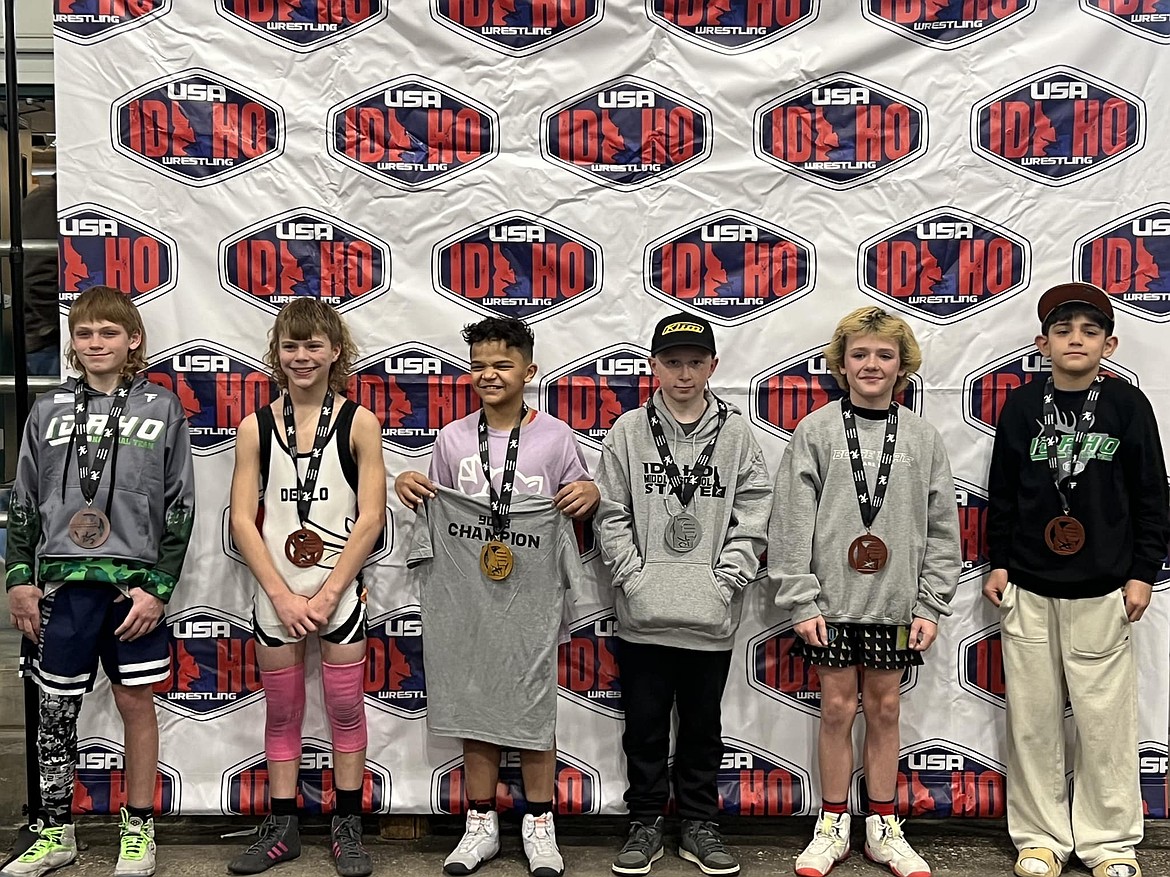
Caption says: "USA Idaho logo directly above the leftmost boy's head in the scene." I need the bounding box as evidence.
[57,203,179,311]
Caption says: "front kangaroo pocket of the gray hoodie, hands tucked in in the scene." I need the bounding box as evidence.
[618,561,731,637]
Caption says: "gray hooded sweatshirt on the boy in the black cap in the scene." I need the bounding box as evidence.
[593,391,772,651]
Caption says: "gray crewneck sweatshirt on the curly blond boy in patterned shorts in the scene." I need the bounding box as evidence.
[768,402,962,624]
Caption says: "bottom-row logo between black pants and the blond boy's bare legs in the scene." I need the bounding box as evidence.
[715,737,812,816]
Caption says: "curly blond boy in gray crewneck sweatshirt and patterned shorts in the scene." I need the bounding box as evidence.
[769,308,961,877]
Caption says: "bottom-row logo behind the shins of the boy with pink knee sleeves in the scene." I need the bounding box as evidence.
[220,743,392,816]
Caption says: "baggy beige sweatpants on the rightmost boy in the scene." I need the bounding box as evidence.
[1000,583,1143,868]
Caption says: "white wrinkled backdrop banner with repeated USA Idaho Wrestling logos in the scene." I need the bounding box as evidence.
[55,0,1170,817]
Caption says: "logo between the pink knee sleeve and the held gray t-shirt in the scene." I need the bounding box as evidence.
[365,606,427,719]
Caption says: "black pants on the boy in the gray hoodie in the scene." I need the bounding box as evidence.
[618,640,731,822]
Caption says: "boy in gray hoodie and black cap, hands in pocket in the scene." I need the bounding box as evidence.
[594,313,772,875]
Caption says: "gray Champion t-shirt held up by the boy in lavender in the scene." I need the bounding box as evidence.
[406,486,581,751]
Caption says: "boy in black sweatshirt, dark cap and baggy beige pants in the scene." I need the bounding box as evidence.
[983,283,1170,877]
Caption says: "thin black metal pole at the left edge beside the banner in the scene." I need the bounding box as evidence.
[4,0,41,821]
